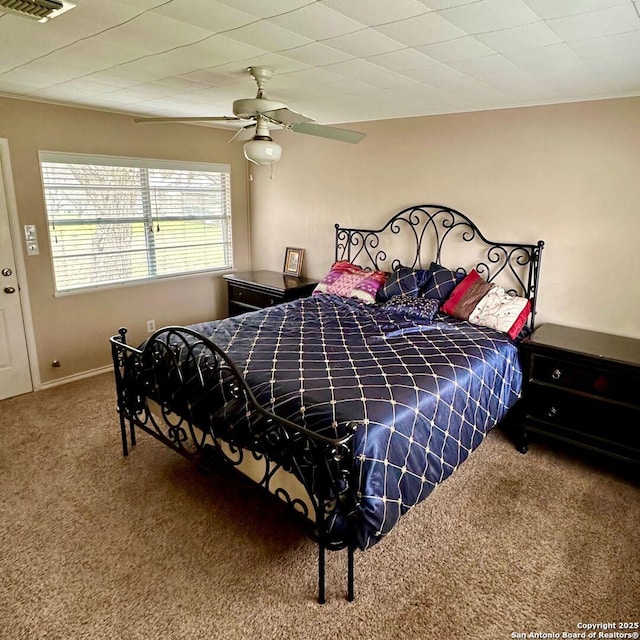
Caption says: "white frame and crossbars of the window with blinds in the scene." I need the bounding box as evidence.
[38,150,234,297]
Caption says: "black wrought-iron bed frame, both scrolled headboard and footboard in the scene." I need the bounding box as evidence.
[110,205,544,604]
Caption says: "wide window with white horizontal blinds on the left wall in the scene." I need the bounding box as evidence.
[40,152,232,293]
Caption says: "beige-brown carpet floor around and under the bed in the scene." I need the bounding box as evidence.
[0,374,640,640]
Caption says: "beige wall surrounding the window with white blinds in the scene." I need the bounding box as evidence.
[0,98,250,382]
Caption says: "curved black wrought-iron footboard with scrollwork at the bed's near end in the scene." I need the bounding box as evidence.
[110,327,356,603]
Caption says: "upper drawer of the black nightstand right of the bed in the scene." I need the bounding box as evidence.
[530,354,640,406]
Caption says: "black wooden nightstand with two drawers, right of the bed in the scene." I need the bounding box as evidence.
[518,324,640,465]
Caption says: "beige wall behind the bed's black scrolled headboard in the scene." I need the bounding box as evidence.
[250,98,640,338]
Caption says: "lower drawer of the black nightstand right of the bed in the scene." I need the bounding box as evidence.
[527,384,640,452]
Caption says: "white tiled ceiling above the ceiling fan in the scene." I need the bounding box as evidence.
[0,0,640,129]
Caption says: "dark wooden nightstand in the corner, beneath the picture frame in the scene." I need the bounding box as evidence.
[222,271,318,316]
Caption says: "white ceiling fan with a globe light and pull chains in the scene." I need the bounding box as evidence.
[135,67,366,165]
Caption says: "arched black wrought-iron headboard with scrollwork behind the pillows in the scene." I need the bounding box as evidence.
[336,204,544,328]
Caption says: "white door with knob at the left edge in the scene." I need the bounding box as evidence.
[0,154,33,400]
